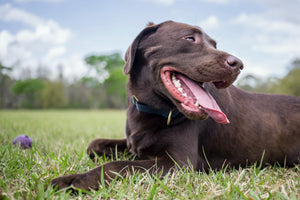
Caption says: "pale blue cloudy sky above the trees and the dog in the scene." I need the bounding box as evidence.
[0,0,300,81]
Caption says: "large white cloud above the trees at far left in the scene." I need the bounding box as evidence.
[0,4,86,80]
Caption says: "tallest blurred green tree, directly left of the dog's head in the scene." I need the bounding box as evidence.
[81,53,127,108]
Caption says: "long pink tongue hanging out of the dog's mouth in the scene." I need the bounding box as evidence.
[178,74,229,124]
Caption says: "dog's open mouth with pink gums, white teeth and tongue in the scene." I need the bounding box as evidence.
[160,66,229,124]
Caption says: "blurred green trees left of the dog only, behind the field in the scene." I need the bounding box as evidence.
[0,53,127,109]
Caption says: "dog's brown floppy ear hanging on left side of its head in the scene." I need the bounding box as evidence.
[123,22,159,75]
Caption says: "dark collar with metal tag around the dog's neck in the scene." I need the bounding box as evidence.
[131,95,185,126]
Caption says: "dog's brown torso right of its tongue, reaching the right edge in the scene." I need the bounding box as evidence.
[199,86,300,168]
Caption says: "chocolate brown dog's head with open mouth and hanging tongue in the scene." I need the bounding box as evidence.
[124,21,243,123]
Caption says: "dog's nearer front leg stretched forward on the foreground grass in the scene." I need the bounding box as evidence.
[51,159,174,191]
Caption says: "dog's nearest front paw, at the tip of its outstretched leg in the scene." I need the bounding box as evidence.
[51,174,99,191]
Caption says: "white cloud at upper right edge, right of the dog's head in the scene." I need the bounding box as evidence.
[233,13,300,55]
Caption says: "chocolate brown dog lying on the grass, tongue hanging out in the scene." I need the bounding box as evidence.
[51,21,300,190]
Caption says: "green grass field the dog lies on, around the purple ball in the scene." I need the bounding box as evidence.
[0,110,300,199]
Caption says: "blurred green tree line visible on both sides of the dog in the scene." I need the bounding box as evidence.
[0,53,300,109]
